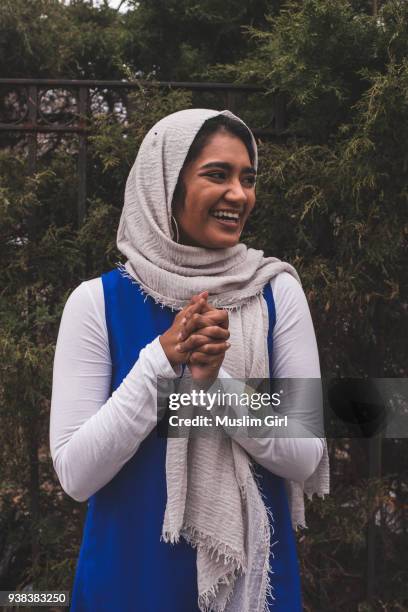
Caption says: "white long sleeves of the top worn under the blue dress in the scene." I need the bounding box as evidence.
[50,272,323,501]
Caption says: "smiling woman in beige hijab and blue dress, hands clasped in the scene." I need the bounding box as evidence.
[50,109,328,612]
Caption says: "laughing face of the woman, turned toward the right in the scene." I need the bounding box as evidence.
[173,132,256,249]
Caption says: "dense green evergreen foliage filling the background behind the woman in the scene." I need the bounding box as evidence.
[0,0,408,611]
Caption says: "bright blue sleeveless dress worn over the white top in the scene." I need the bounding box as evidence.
[71,269,302,612]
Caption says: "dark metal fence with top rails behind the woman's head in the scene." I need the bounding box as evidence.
[0,79,284,224]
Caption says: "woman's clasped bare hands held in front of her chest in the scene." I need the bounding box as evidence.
[160,291,230,381]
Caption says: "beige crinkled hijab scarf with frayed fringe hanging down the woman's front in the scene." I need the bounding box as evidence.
[117,109,329,612]
